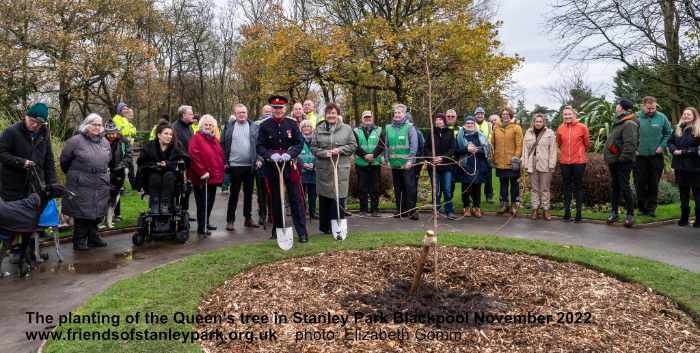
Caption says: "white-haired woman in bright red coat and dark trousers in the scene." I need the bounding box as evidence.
[187,114,224,237]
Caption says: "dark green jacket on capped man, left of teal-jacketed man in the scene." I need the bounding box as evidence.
[603,112,639,164]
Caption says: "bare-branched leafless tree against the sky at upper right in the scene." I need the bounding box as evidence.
[549,0,700,119]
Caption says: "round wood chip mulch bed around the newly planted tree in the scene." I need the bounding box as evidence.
[197,247,700,353]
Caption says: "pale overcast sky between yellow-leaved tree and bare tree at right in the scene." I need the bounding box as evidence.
[498,0,621,108]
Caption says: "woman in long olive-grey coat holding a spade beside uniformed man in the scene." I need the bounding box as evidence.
[311,103,357,234]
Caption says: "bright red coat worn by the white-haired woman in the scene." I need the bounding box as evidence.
[187,132,224,186]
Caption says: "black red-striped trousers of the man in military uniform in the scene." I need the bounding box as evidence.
[265,162,308,236]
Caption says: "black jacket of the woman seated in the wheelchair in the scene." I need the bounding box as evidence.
[135,140,190,193]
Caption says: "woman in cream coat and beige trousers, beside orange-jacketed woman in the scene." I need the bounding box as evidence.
[523,113,557,221]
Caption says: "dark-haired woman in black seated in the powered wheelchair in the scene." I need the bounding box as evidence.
[136,120,190,214]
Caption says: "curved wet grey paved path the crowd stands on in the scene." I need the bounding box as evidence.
[0,195,700,353]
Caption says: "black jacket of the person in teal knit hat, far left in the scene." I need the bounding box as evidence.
[0,121,56,201]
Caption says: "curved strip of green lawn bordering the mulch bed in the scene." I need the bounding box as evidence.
[44,233,700,353]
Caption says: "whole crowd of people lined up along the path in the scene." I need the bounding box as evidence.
[0,96,700,250]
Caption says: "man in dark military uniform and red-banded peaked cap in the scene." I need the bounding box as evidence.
[257,96,308,243]
